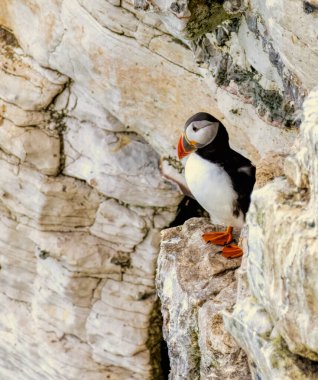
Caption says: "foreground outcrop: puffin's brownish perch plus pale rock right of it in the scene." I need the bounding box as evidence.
[157,89,318,380]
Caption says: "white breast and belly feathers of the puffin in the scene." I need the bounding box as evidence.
[185,153,244,227]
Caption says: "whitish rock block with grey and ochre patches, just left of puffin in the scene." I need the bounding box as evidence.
[63,121,180,207]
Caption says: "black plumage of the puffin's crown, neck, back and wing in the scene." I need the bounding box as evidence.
[191,112,256,216]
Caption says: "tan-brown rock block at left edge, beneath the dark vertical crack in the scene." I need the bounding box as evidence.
[0,157,102,231]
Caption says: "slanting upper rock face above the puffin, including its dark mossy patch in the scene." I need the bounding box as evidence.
[0,0,298,166]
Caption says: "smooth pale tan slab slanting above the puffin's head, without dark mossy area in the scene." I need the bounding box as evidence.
[0,0,298,161]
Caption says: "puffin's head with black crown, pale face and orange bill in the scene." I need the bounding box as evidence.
[178,112,225,159]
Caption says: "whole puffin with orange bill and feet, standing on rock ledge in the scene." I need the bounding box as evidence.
[178,112,256,258]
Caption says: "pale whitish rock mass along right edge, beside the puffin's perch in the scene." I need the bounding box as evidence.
[226,89,318,379]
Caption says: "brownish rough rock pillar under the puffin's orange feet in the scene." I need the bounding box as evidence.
[157,218,250,380]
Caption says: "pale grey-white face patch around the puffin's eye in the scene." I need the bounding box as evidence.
[185,120,219,148]
